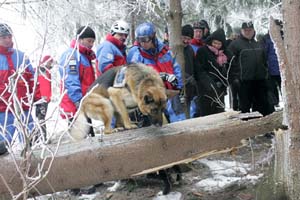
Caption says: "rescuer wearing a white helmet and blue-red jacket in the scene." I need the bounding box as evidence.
[96,20,129,76]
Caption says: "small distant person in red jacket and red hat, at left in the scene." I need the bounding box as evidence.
[35,55,54,139]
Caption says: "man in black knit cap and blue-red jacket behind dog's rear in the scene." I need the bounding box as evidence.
[59,26,96,120]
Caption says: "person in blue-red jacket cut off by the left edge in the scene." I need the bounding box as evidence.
[0,23,40,155]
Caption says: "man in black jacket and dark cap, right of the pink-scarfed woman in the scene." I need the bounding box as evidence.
[228,22,274,115]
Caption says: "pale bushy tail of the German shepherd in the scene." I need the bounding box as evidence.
[69,111,91,141]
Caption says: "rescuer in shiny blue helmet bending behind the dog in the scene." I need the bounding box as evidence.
[128,22,186,122]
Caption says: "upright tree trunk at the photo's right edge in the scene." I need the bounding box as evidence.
[276,0,300,200]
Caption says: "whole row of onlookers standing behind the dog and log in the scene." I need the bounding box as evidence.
[0,20,281,154]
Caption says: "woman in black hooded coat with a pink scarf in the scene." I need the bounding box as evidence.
[196,29,229,116]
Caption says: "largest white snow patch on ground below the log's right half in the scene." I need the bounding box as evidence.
[196,159,263,192]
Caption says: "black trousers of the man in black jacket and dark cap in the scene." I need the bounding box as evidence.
[239,80,275,116]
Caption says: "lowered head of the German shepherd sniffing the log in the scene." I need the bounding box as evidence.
[138,79,167,126]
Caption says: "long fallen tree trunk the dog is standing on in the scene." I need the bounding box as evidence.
[0,112,282,199]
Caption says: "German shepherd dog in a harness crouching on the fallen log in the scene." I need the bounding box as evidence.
[70,64,167,140]
